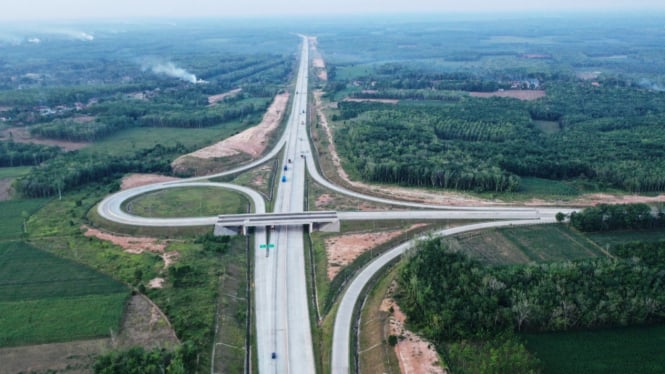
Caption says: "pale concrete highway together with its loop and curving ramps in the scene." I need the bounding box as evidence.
[97,36,571,373]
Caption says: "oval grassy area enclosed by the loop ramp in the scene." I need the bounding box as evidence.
[124,187,248,218]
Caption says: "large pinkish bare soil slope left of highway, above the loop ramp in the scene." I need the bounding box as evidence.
[171,93,289,170]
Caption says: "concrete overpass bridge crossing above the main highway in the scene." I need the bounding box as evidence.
[215,211,339,235]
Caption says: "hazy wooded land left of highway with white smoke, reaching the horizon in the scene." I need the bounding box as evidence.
[0,23,298,197]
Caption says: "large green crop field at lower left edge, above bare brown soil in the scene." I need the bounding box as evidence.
[0,242,129,346]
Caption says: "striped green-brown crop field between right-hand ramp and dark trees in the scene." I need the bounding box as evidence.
[450,224,602,265]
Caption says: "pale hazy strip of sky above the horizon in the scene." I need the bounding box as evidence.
[0,0,665,20]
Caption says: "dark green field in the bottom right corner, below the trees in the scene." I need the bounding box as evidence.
[523,325,665,374]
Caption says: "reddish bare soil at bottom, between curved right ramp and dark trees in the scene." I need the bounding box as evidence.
[381,282,447,374]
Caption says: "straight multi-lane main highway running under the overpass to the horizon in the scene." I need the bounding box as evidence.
[255,38,315,374]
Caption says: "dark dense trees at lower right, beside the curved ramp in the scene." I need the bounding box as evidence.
[398,234,665,372]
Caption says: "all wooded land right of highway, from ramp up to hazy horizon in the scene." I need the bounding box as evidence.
[319,17,665,193]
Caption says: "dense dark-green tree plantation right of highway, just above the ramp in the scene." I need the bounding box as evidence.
[333,77,665,192]
